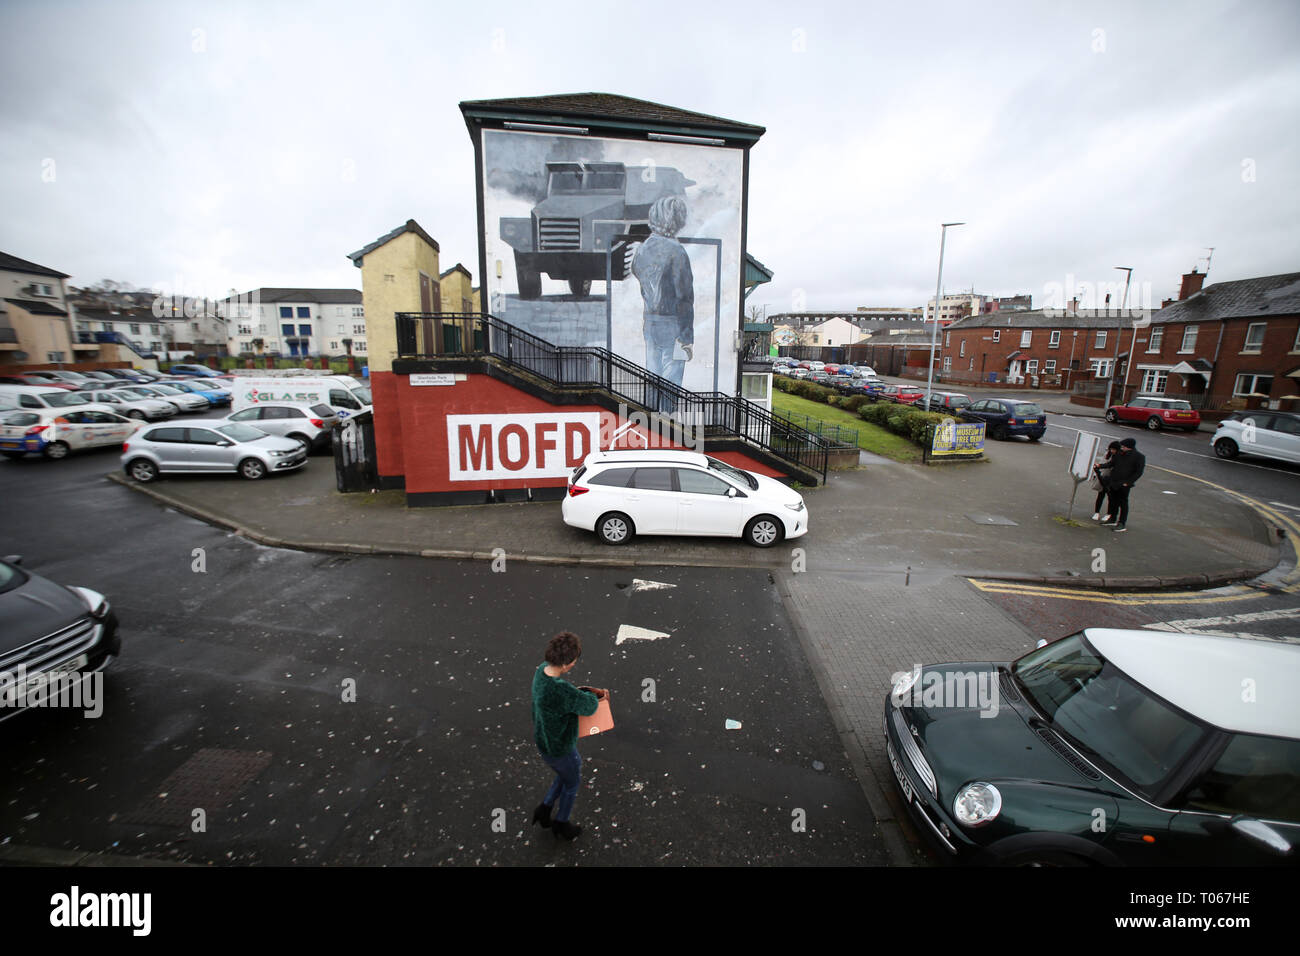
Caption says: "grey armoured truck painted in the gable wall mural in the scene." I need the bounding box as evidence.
[501,163,696,299]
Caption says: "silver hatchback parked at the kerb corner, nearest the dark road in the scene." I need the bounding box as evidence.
[122,421,307,481]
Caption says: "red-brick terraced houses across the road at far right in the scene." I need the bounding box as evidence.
[937,272,1300,410]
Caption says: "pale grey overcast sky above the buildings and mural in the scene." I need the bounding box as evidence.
[0,0,1300,312]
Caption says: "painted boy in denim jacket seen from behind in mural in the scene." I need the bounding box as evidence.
[632,196,696,414]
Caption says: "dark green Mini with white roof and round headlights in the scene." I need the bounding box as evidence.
[884,628,1300,866]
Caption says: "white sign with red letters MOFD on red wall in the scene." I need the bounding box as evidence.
[447,411,601,481]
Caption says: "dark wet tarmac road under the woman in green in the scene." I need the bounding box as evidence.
[0,451,885,865]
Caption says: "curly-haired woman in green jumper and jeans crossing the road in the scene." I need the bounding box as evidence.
[533,631,610,840]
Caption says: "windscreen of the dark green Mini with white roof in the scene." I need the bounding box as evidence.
[1011,635,1208,796]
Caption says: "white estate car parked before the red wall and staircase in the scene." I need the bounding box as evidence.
[560,450,809,548]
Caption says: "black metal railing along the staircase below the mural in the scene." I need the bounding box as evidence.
[395,312,831,484]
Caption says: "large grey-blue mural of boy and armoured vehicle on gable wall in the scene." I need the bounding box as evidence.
[482,130,744,394]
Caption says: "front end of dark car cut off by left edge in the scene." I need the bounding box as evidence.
[0,555,122,721]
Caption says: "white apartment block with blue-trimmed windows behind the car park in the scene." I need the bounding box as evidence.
[221,287,367,358]
